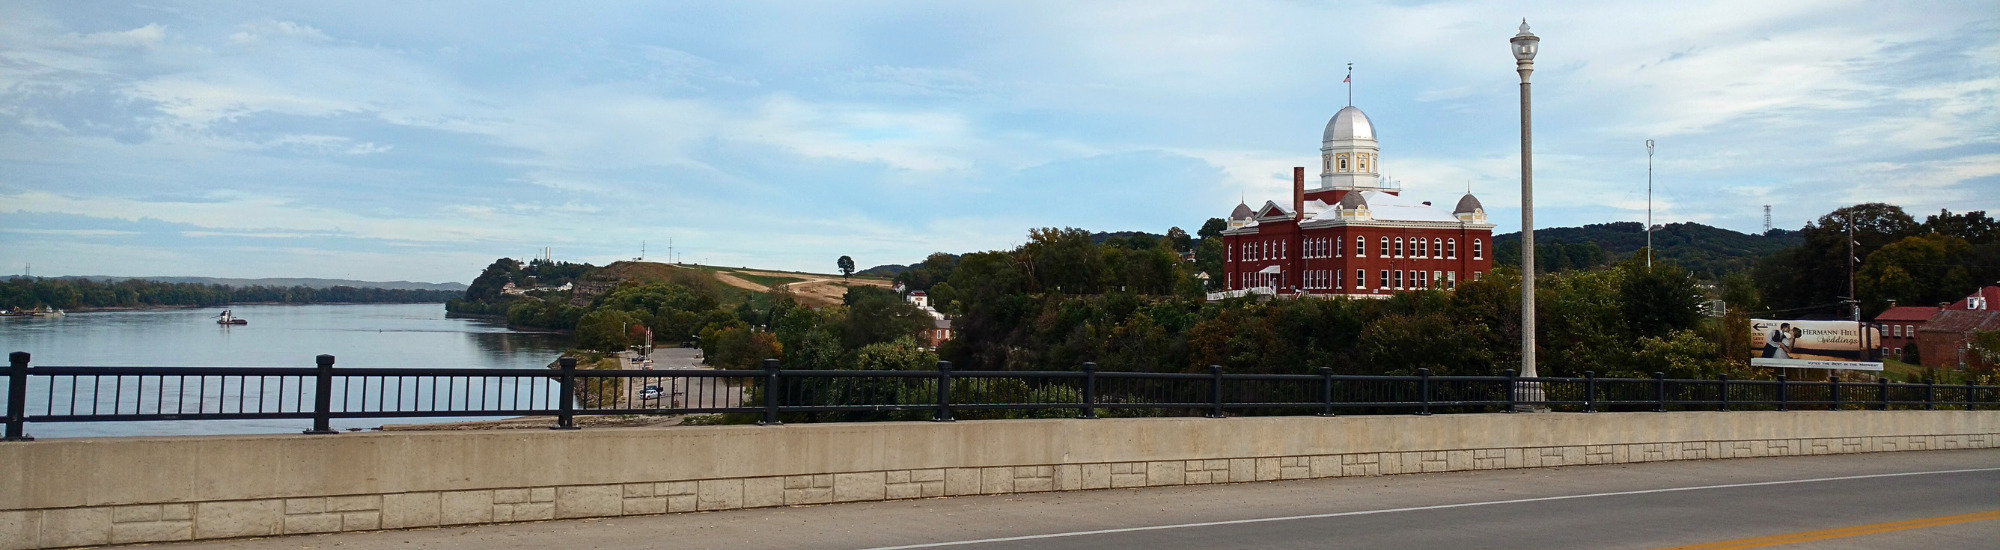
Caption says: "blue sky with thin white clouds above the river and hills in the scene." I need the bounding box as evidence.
[0,0,2000,282]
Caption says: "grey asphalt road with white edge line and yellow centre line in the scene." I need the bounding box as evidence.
[148,450,2000,550]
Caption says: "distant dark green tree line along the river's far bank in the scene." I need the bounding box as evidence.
[0,276,458,310]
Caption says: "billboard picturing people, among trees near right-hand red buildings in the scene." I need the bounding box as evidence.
[1750,318,1882,370]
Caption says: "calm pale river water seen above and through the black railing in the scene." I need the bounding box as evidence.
[0,304,570,438]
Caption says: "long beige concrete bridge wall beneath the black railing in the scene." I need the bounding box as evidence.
[0,410,2000,548]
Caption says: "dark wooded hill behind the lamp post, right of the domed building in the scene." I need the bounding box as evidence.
[1494,222,1804,280]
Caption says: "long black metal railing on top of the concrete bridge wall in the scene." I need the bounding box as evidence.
[4,352,2000,440]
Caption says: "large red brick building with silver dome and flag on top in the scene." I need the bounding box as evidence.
[1210,106,1494,298]
